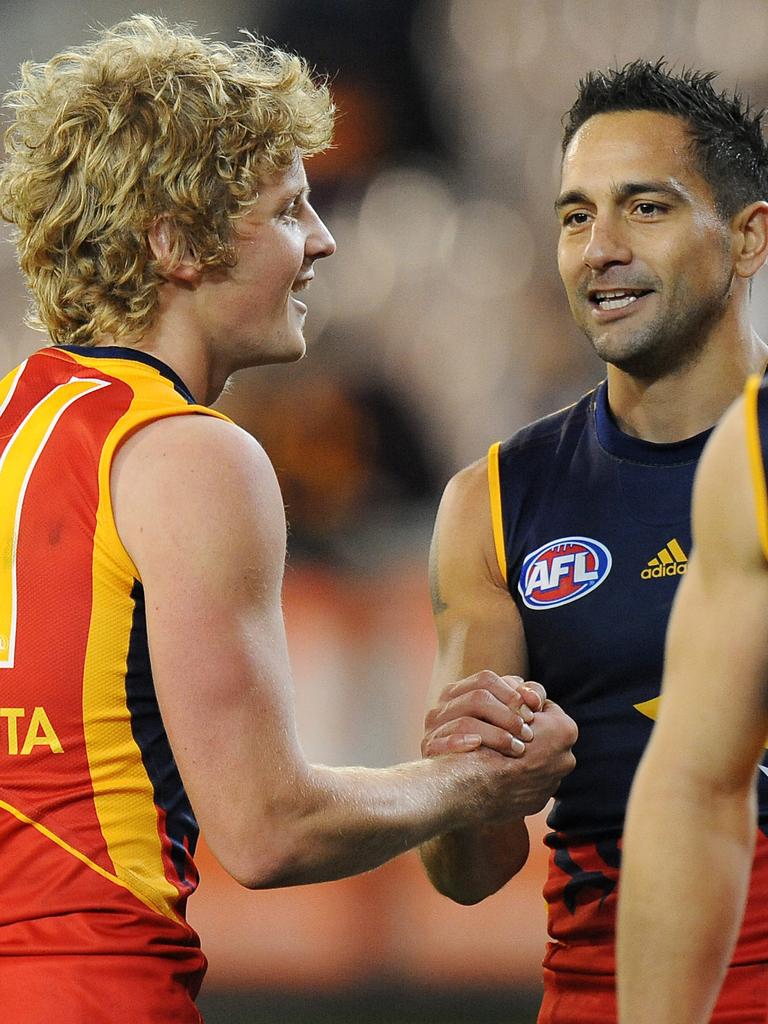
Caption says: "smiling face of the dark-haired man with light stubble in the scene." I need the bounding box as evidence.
[556,111,733,379]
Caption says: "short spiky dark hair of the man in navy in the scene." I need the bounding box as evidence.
[562,57,768,220]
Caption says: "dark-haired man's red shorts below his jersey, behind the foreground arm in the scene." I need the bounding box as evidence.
[538,964,768,1024]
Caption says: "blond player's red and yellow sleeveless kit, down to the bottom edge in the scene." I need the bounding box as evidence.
[0,347,230,1024]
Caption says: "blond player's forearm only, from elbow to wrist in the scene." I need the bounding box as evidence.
[218,752,518,888]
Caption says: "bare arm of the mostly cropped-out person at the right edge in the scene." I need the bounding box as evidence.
[617,402,768,1024]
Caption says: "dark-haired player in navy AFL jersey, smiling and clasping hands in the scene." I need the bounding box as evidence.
[423,61,768,1024]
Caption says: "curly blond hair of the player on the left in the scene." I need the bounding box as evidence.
[0,14,334,345]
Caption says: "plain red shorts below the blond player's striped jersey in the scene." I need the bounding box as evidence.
[0,955,203,1024]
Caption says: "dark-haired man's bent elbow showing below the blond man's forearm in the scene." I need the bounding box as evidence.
[420,819,529,904]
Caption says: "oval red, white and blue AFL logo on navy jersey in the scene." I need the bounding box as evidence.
[517,537,611,608]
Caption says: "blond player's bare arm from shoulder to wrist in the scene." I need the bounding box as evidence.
[112,416,561,888]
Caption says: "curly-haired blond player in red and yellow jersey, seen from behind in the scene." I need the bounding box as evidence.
[0,16,574,1024]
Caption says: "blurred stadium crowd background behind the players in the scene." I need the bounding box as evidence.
[0,0,768,1024]
